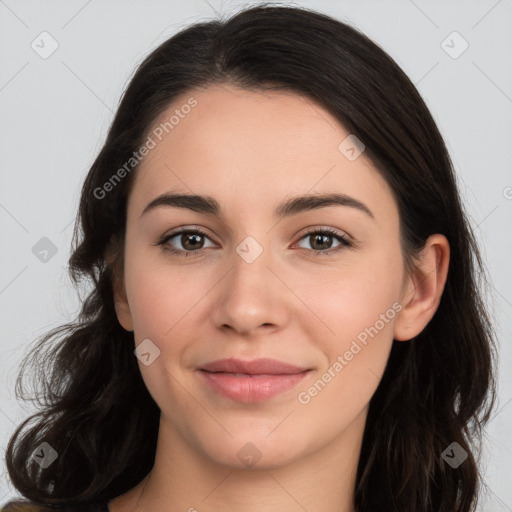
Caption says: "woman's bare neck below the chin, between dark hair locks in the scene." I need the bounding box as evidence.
[113,408,367,512]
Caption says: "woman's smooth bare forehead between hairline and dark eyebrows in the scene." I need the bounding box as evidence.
[126,85,392,222]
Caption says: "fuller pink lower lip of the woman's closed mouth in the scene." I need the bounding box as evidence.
[200,370,309,403]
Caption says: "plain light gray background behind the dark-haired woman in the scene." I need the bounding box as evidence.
[0,0,512,512]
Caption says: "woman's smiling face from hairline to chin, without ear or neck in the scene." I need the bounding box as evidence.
[116,86,406,468]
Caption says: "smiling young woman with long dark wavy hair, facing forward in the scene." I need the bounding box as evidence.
[4,5,494,512]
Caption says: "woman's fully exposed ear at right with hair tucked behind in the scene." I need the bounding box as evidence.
[394,234,450,341]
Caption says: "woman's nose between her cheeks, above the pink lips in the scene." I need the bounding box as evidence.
[212,241,293,337]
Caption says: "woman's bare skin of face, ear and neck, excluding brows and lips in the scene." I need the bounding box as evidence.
[109,85,449,512]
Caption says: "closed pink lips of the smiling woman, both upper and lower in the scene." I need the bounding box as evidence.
[199,359,310,403]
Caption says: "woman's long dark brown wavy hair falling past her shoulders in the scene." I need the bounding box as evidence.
[1,4,495,512]
